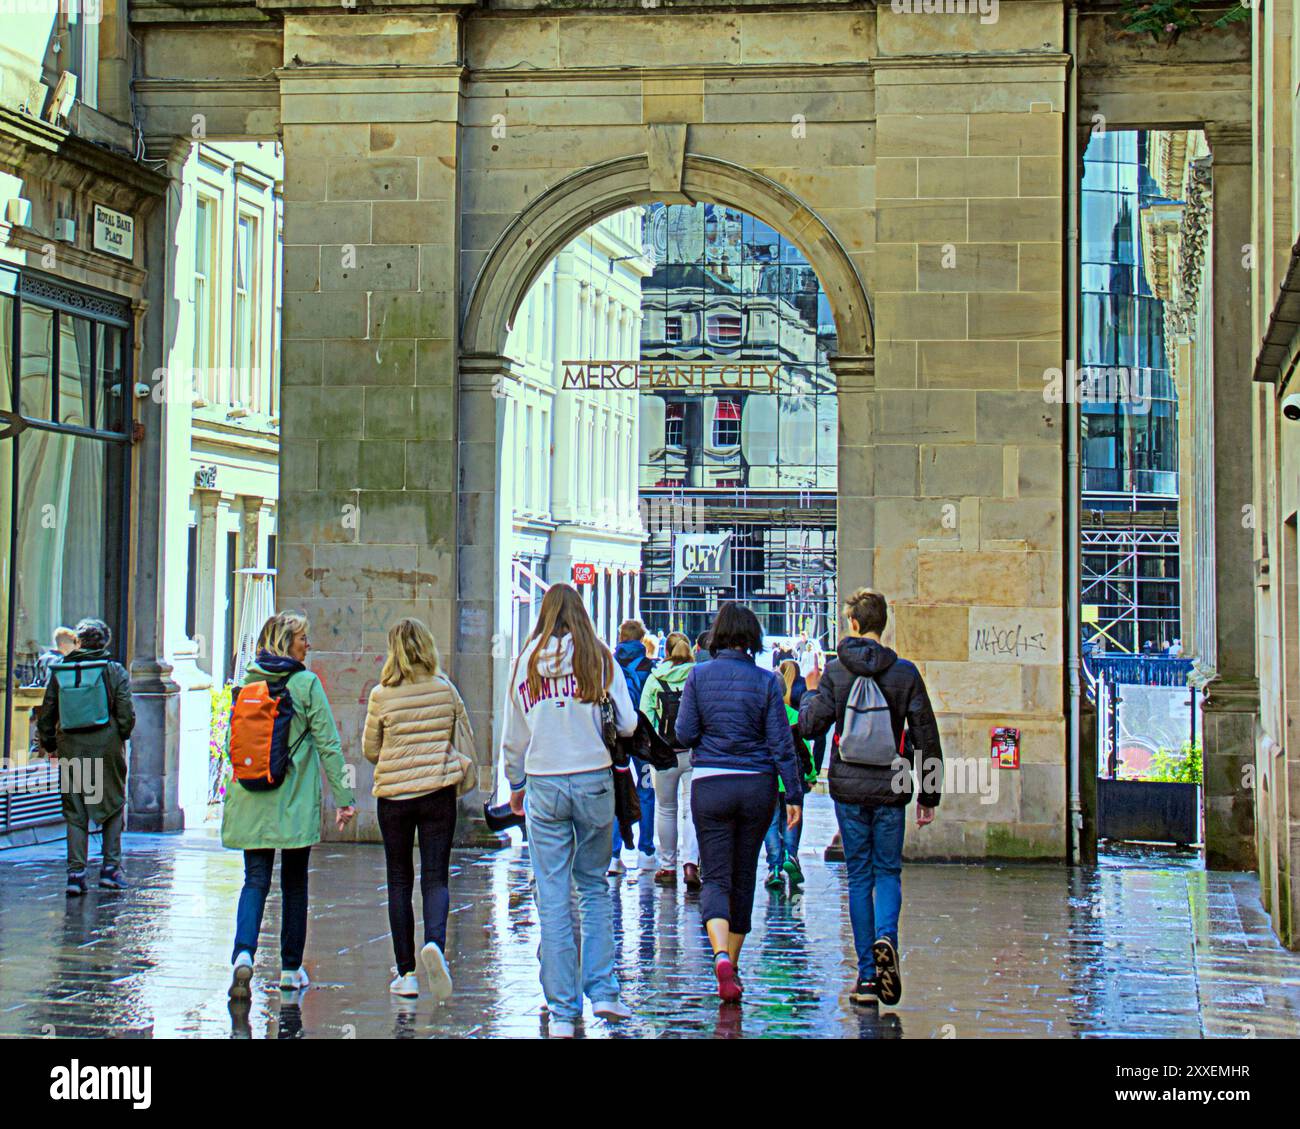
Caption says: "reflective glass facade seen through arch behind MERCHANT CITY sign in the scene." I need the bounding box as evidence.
[640,204,839,643]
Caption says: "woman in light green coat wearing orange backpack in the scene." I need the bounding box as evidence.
[221,611,356,1000]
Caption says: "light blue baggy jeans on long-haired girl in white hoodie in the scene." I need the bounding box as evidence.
[525,769,619,1021]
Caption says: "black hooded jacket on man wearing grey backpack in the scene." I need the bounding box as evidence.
[800,636,944,808]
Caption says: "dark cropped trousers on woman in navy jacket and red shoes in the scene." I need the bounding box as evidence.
[690,773,776,933]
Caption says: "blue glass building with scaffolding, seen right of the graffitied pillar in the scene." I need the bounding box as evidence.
[1080,130,1180,652]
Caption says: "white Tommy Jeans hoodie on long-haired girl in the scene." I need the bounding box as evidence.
[501,635,637,792]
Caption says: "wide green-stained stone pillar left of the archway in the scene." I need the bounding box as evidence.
[277,12,470,842]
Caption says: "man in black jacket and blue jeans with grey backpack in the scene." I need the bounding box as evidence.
[800,588,944,1005]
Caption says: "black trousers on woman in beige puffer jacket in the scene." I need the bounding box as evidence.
[378,784,456,976]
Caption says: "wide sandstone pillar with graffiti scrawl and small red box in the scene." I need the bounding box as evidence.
[868,17,1069,860]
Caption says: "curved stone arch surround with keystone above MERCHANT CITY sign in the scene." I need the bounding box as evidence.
[455,147,874,785]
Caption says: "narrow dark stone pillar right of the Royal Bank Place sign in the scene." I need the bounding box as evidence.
[126,140,190,831]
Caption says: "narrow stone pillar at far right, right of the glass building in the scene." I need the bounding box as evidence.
[1197,122,1260,870]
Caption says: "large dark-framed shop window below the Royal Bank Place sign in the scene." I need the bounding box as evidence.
[0,269,131,749]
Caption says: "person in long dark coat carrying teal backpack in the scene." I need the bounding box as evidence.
[36,619,135,897]
